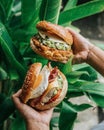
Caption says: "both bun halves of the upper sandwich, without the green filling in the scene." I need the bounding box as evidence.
[30,21,73,63]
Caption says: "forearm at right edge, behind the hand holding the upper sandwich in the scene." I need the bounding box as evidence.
[86,45,104,76]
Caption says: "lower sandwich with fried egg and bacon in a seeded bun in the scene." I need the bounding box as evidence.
[20,63,68,110]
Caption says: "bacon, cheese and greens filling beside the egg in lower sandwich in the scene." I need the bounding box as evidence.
[40,68,63,105]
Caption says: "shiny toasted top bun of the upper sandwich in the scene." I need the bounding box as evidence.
[36,21,73,45]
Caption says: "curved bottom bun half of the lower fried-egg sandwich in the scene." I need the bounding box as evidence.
[30,71,68,110]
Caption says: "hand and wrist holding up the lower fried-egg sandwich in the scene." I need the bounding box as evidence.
[12,89,53,130]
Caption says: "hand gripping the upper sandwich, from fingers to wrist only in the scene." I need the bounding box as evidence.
[67,28,93,64]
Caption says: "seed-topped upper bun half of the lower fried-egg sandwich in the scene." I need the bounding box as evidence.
[20,63,42,103]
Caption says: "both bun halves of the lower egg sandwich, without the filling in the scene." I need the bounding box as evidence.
[20,63,68,110]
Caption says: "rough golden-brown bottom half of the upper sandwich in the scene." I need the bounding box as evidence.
[30,37,73,63]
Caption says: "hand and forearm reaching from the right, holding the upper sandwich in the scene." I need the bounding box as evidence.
[67,28,104,76]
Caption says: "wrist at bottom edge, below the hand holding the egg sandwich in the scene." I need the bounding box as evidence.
[26,122,49,130]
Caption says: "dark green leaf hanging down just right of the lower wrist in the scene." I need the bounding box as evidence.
[59,102,77,130]
